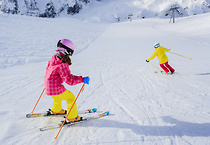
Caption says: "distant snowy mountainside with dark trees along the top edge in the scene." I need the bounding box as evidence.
[0,0,210,21]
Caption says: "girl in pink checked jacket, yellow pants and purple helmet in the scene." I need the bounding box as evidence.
[44,39,90,122]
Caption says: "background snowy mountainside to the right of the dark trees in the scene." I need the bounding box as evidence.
[75,0,210,22]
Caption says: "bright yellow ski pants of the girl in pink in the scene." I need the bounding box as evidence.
[51,90,77,119]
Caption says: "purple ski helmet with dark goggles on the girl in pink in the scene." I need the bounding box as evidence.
[57,39,75,56]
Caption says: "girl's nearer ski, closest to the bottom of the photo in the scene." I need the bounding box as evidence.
[39,111,109,131]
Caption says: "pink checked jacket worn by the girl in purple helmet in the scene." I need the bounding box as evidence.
[44,55,83,96]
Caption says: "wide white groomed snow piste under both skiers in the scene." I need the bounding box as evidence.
[0,13,210,145]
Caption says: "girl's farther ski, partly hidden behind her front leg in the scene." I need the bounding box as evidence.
[26,108,97,118]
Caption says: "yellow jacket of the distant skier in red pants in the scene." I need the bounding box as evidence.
[147,46,169,64]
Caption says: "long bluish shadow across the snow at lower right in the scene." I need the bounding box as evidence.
[75,116,210,137]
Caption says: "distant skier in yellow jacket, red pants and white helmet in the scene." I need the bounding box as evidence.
[146,43,175,74]
